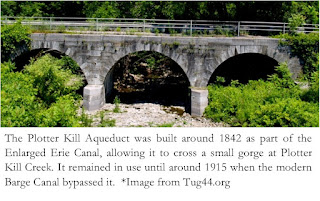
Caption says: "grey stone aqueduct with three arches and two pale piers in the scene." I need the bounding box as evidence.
[31,34,301,116]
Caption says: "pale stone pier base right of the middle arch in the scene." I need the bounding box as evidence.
[191,88,208,117]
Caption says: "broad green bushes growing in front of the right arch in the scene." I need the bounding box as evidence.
[205,64,319,127]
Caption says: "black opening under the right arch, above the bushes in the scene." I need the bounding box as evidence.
[208,53,278,85]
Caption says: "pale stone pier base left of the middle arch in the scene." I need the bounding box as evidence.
[83,85,106,111]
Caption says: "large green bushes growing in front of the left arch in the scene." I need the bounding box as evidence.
[1,55,82,127]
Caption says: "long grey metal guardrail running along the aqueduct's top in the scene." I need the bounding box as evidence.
[1,16,319,36]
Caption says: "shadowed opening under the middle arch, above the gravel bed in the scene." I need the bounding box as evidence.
[104,51,190,112]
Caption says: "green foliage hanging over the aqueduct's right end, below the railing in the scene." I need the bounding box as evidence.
[278,33,319,77]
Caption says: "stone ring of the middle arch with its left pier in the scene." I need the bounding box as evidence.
[80,41,192,111]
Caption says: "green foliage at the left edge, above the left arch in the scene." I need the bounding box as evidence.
[1,22,31,62]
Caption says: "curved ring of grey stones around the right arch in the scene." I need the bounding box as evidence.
[208,45,302,84]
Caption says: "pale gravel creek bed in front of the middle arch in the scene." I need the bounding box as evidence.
[82,103,227,127]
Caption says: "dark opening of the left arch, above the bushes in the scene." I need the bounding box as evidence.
[13,48,88,95]
